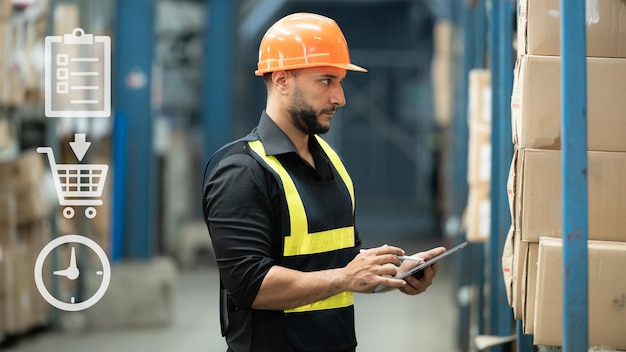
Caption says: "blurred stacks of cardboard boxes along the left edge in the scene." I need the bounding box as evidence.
[0,0,51,340]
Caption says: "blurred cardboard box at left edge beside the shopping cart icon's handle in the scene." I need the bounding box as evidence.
[0,150,46,193]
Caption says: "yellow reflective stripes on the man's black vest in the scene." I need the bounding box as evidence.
[248,136,355,313]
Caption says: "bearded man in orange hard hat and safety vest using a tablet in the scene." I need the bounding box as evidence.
[203,13,445,352]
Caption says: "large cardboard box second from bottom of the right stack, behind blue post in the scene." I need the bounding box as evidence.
[513,149,626,242]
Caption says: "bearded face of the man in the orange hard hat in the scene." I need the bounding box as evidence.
[288,67,346,135]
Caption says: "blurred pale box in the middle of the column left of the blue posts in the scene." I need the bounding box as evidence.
[467,124,491,185]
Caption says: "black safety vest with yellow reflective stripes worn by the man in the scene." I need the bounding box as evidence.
[247,136,356,350]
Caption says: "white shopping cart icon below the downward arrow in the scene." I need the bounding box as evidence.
[37,147,109,219]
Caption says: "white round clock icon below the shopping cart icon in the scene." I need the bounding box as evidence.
[35,235,111,312]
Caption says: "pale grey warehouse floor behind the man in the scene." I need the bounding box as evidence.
[0,235,457,352]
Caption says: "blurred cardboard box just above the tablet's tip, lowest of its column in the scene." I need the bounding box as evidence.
[466,184,491,242]
